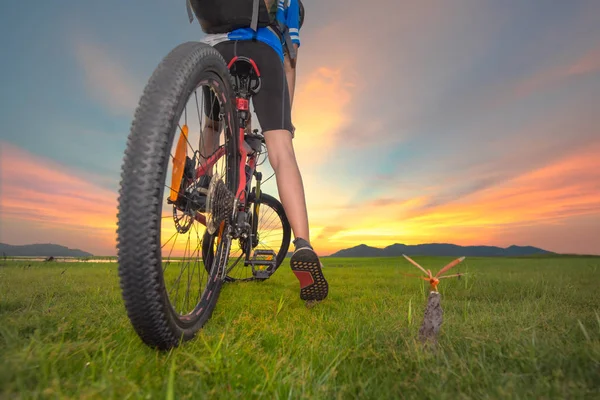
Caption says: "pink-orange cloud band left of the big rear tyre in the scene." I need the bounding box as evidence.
[0,142,117,254]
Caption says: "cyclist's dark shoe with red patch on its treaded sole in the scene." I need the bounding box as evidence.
[290,248,329,301]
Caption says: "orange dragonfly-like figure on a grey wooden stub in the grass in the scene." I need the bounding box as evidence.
[403,254,465,345]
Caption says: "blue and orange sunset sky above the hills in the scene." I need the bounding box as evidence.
[0,0,600,255]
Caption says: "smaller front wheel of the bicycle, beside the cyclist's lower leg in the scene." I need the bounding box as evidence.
[202,192,291,281]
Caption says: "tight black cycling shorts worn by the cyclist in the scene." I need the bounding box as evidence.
[204,40,294,135]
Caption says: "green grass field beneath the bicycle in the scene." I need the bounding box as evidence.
[0,257,600,399]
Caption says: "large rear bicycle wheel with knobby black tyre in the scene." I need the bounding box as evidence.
[117,42,238,349]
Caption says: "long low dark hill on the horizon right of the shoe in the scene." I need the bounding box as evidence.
[329,243,554,257]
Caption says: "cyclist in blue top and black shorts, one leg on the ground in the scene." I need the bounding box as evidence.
[202,0,329,300]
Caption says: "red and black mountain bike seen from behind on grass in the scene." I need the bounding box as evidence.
[117,42,291,350]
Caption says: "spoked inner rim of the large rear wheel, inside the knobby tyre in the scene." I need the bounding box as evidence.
[160,72,234,324]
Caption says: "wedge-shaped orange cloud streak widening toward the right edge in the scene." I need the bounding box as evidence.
[413,149,600,228]
